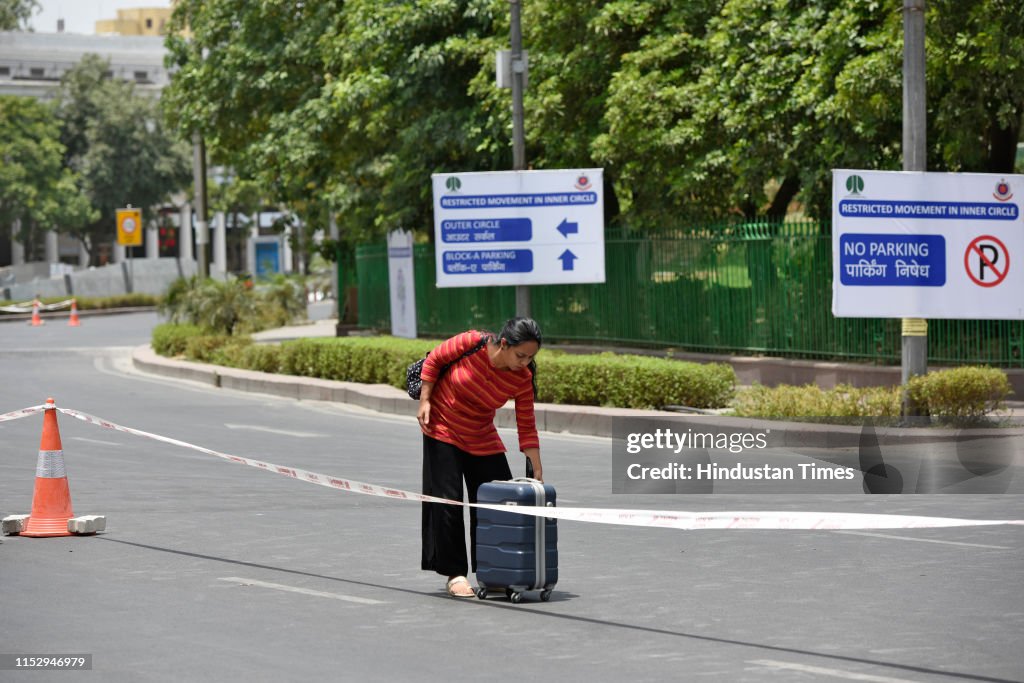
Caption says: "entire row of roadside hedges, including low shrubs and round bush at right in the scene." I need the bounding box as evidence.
[153,324,1011,422]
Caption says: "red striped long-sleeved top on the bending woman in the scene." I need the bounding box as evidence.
[421,330,541,456]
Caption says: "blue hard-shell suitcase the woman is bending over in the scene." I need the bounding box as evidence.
[476,478,558,602]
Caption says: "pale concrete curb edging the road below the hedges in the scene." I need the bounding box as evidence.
[132,344,1024,449]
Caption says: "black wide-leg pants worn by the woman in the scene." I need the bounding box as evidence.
[421,434,512,577]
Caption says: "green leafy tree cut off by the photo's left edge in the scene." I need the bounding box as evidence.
[0,95,95,253]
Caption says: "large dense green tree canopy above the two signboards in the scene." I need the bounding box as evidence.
[163,0,1024,241]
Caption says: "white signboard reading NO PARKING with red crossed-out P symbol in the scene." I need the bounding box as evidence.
[833,170,1024,319]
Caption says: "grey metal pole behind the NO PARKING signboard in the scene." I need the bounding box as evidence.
[900,0,928,417]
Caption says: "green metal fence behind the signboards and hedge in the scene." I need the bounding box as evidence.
[356,222,1024,368]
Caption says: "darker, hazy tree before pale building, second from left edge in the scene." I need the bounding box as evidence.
[57,55,190,262]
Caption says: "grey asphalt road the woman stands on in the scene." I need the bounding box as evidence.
[0,314,1024,682]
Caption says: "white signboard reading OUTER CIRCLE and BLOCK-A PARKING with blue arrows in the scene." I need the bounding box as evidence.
[432,169,604,287]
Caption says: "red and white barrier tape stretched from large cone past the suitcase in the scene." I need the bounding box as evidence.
[6,405,1024,530]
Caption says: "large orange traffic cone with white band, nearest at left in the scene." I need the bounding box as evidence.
[22,398,75,537]
